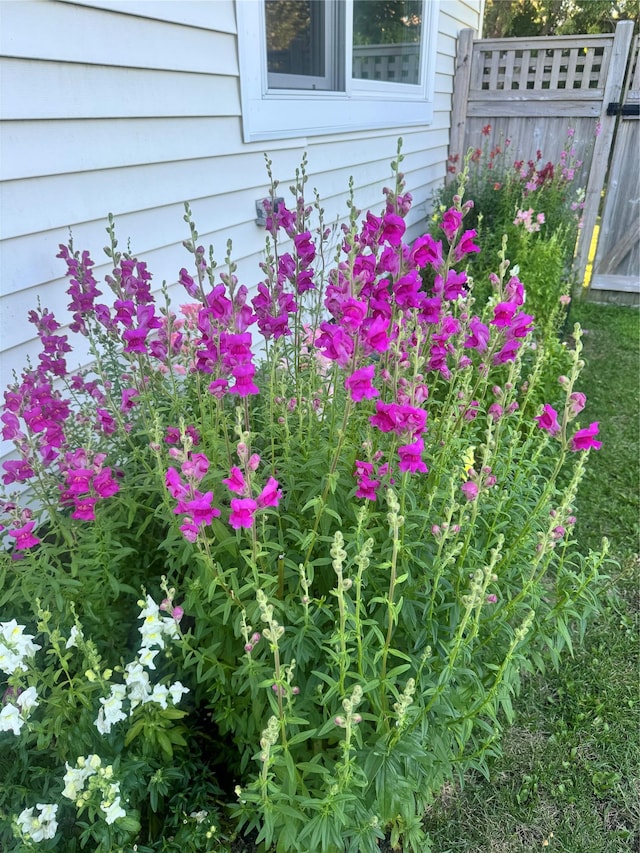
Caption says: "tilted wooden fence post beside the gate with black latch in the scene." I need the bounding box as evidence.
[575,21,633,282]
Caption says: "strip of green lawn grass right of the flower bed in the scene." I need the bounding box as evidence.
[426,303,640,853]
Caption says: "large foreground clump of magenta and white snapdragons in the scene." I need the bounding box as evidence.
[0,145,605,853]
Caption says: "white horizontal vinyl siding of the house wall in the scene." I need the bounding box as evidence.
[0,0,480,388]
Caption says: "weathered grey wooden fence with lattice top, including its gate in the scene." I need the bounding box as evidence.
[449,21,640,300]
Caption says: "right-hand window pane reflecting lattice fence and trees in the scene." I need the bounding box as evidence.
[352,0,423,85]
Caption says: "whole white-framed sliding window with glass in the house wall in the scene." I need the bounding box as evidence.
[236,0,438,142]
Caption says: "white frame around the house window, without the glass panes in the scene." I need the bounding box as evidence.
[236,0,440,143]
